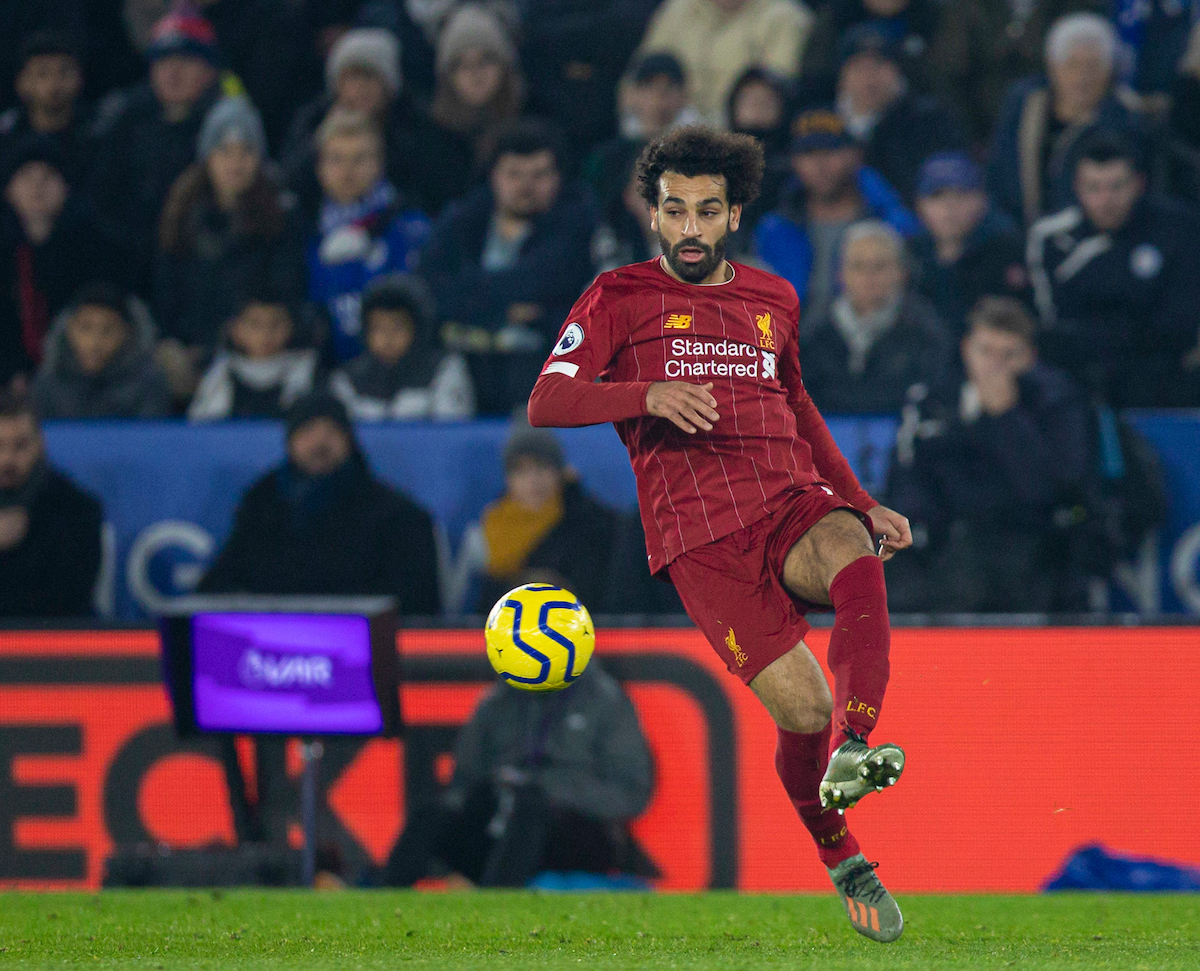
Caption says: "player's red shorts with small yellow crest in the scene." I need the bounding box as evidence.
[668,485,872,684]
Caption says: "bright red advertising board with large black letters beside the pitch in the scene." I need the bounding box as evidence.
[0,628,1200,892]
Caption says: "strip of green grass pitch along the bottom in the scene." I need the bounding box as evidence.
[0,891,1200,971]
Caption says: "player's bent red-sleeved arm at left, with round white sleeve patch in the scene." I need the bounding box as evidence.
[529,274,719,433]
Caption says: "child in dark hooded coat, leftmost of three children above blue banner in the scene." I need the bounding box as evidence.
[34,283,170,418]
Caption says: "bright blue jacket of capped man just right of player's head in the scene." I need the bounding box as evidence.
[754,166,920,306]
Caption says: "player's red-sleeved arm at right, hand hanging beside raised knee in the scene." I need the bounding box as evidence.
[779,294,912,559]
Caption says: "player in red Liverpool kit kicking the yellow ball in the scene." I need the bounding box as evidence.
[529,126,912,941]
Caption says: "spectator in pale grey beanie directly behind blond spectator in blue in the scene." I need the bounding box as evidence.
[281,28,440,222]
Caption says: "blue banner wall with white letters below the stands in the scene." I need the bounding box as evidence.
[37,413,1200,619]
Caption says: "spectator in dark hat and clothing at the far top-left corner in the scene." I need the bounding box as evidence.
[0,34,91,184]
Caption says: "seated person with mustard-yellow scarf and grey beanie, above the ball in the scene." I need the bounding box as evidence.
[452,424,617,613]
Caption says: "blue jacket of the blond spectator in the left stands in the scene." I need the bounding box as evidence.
[305,209,430,361]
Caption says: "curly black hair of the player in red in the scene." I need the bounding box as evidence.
[635,125,764,209]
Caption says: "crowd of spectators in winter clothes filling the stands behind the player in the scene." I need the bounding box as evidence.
[0,0,1200,616]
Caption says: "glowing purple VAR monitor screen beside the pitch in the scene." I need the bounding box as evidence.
[192,613,383,735]
